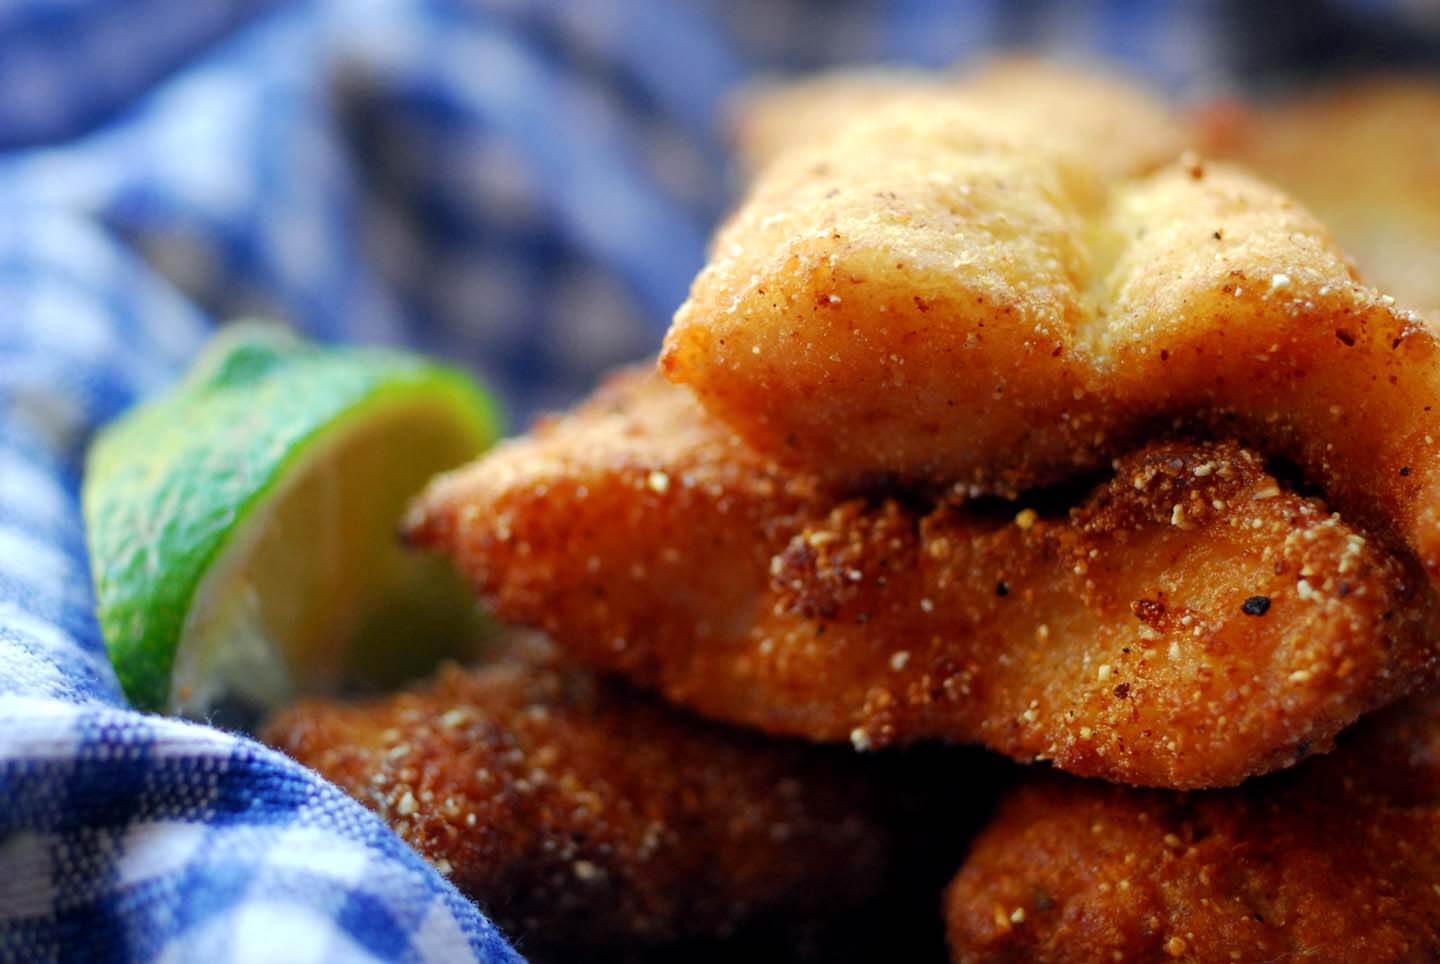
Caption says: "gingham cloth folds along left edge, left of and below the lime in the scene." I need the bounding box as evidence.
[0,212,520,961]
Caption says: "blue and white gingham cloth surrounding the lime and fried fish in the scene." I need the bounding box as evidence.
[0,0,1436,964]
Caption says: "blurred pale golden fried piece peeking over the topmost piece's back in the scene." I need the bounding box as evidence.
[733,58,1194,177]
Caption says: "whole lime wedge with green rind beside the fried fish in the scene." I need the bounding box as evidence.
[84,323,498,725]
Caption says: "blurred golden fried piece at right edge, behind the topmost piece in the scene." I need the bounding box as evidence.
[1198,79,1440,317]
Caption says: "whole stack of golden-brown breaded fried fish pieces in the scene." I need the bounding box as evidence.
[269,62,1440,961]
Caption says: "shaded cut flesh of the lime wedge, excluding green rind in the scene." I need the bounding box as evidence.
[166,391,488,718]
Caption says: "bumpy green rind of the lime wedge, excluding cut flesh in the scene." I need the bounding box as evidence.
[82,323,501,710]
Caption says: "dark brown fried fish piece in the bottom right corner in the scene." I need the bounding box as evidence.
[946,696,1440,961]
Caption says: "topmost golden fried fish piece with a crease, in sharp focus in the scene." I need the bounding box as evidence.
[661,102,1440,578]
